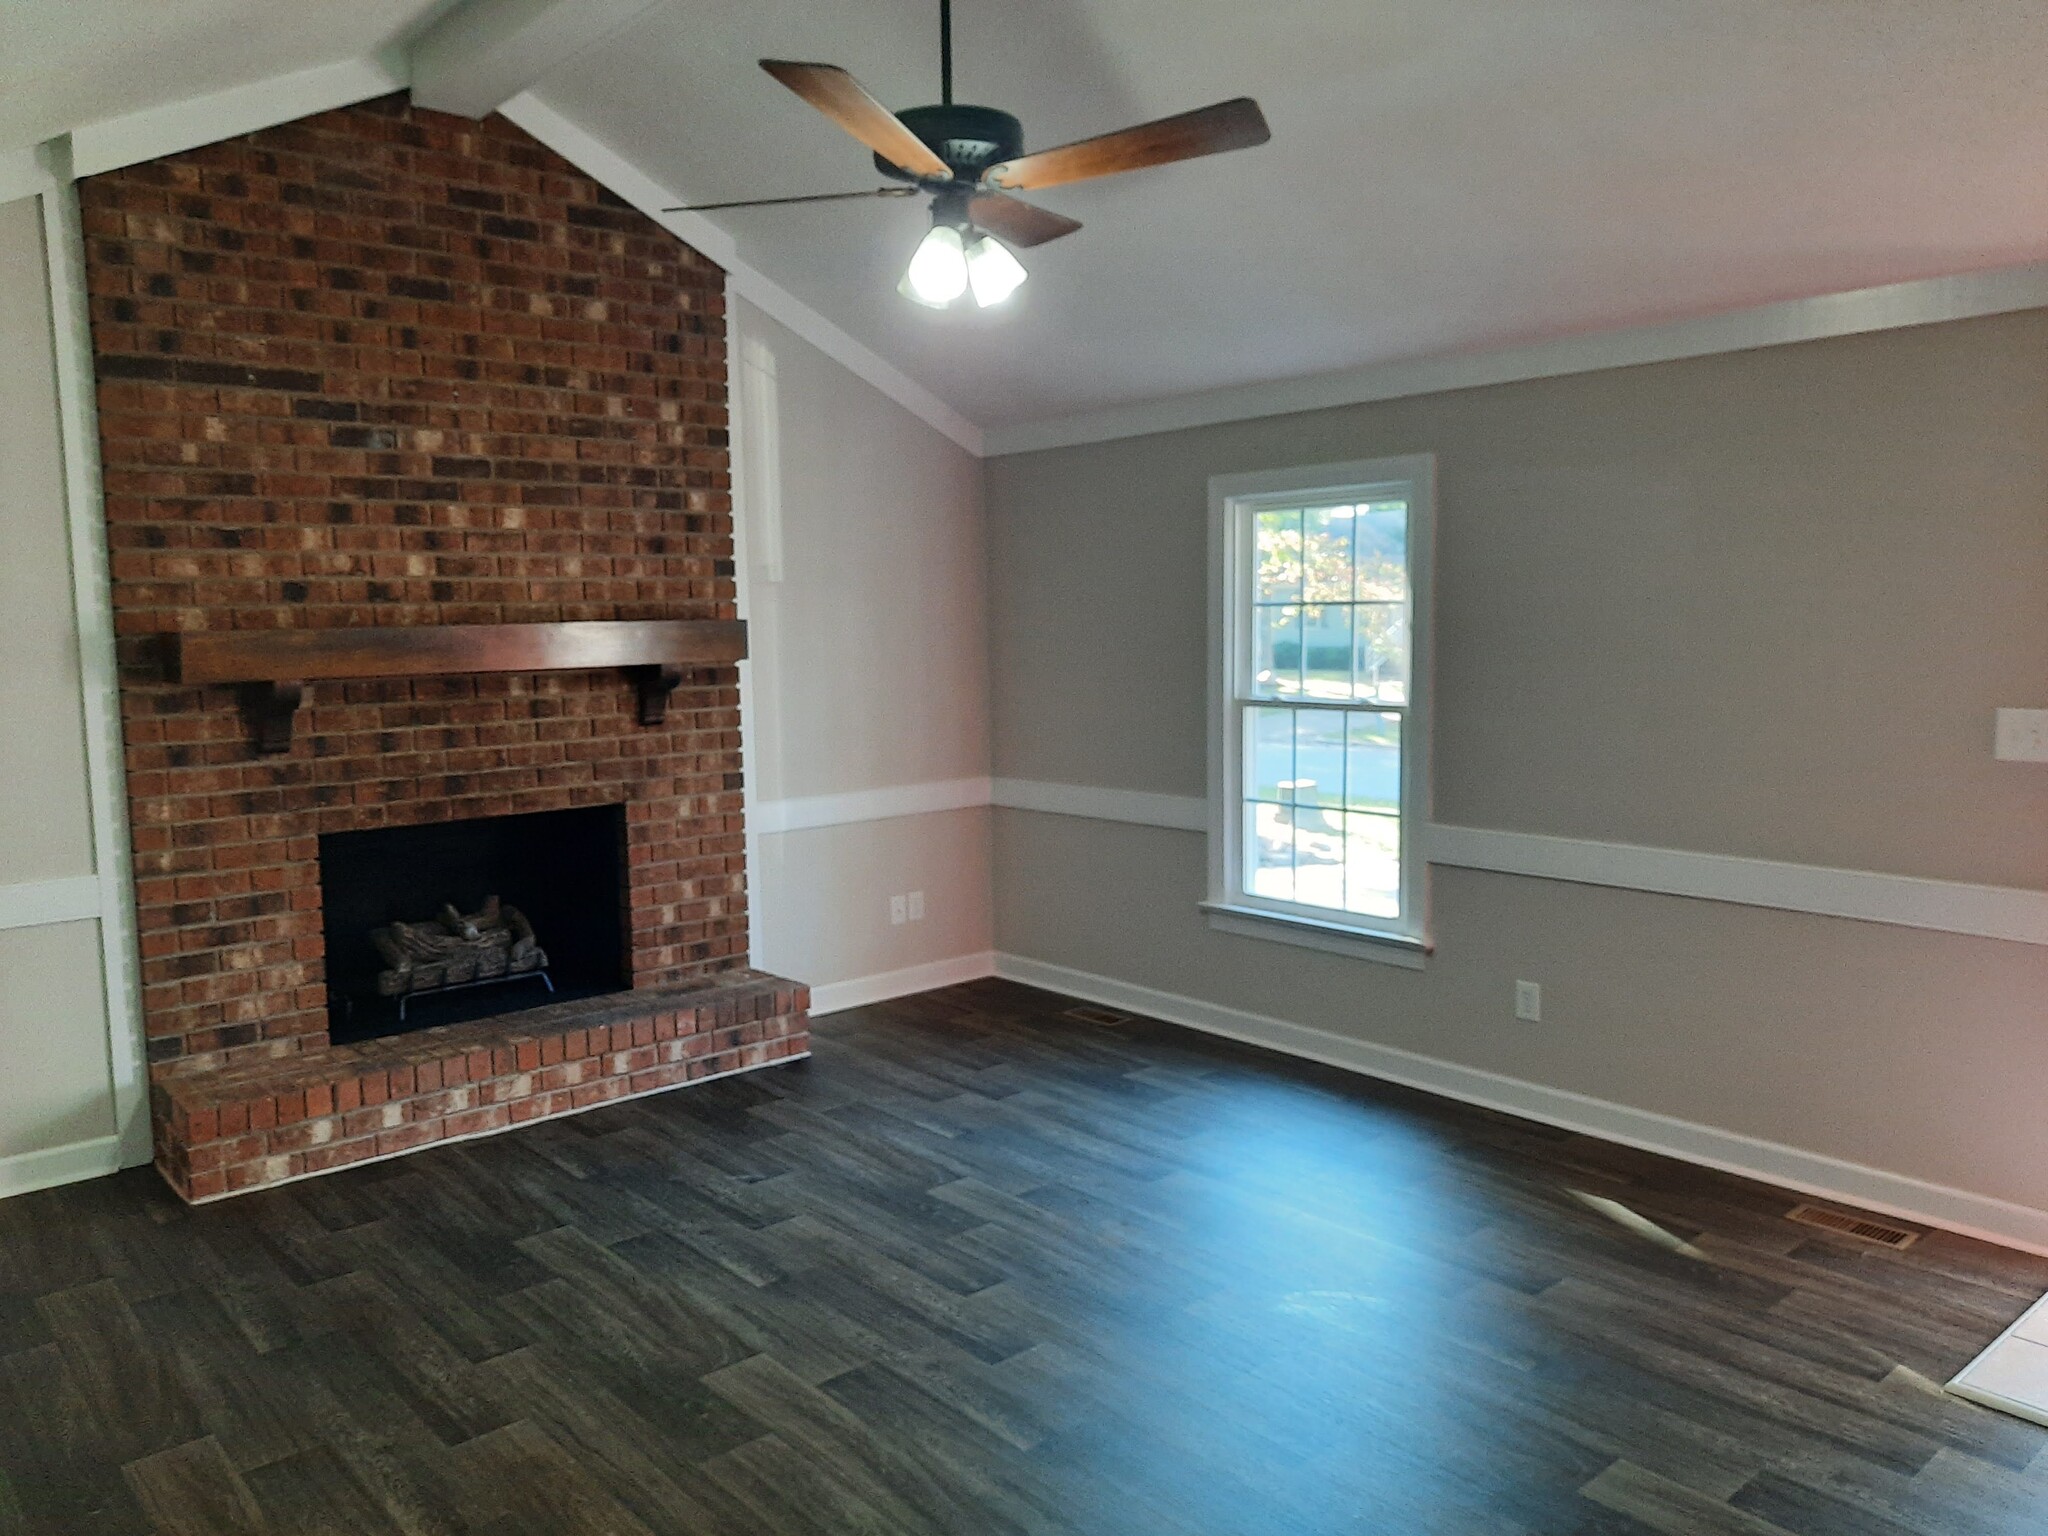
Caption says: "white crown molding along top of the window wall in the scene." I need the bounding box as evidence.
[983,262,2048,459]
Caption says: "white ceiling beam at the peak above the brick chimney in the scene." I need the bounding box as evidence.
[412,0,662,117]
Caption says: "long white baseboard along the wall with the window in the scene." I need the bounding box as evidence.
[995,954,2048,1255]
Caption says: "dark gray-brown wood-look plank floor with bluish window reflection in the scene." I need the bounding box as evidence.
[0,981,2048,1536]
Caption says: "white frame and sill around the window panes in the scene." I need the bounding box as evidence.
[1202,453,1436,967]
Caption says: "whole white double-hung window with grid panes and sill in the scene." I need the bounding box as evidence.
[1206,455,1434,963]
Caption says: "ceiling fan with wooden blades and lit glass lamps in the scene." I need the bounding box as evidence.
[664,0,1272,309]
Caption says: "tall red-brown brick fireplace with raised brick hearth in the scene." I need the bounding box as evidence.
[78,98,807,1200]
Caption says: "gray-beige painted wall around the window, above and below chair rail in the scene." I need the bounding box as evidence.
[987,311,2048,1208]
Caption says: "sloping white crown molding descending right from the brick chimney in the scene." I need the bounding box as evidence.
[498,92,981,455]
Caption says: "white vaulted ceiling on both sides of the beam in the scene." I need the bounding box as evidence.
[12,0,2048,426]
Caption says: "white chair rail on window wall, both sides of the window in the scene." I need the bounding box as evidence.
[993,778,2048,944]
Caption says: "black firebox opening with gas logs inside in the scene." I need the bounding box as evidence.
[319,805,631,1044]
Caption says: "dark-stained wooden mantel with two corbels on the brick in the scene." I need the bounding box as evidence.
[168,618,748,752]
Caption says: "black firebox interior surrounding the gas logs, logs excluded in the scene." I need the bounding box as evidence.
[319,805,629,1044]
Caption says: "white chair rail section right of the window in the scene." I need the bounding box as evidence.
[1425,825,2048,944]
